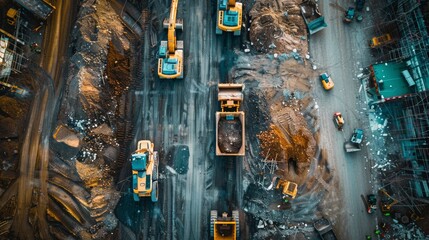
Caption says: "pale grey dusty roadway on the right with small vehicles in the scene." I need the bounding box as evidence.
[310,1,376,239]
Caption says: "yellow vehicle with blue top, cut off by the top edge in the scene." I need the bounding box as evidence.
[216,0,243,36]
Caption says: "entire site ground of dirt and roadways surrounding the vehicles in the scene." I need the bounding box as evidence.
[0,0,424,239]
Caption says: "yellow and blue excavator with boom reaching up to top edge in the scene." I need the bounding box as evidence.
[158,0,183,79]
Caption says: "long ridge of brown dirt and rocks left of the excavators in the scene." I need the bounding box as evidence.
[50,0,132,239]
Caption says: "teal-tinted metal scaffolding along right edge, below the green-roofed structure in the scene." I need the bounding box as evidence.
[380,91,429,213]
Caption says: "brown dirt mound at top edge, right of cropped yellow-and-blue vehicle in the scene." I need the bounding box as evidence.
[249,0,308,54]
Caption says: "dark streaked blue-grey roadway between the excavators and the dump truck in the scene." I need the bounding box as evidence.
[131,0,238,239]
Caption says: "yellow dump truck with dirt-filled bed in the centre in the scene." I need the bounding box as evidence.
[216,83,245,156]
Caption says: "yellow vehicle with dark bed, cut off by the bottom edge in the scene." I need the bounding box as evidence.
[210,210,240,240]
